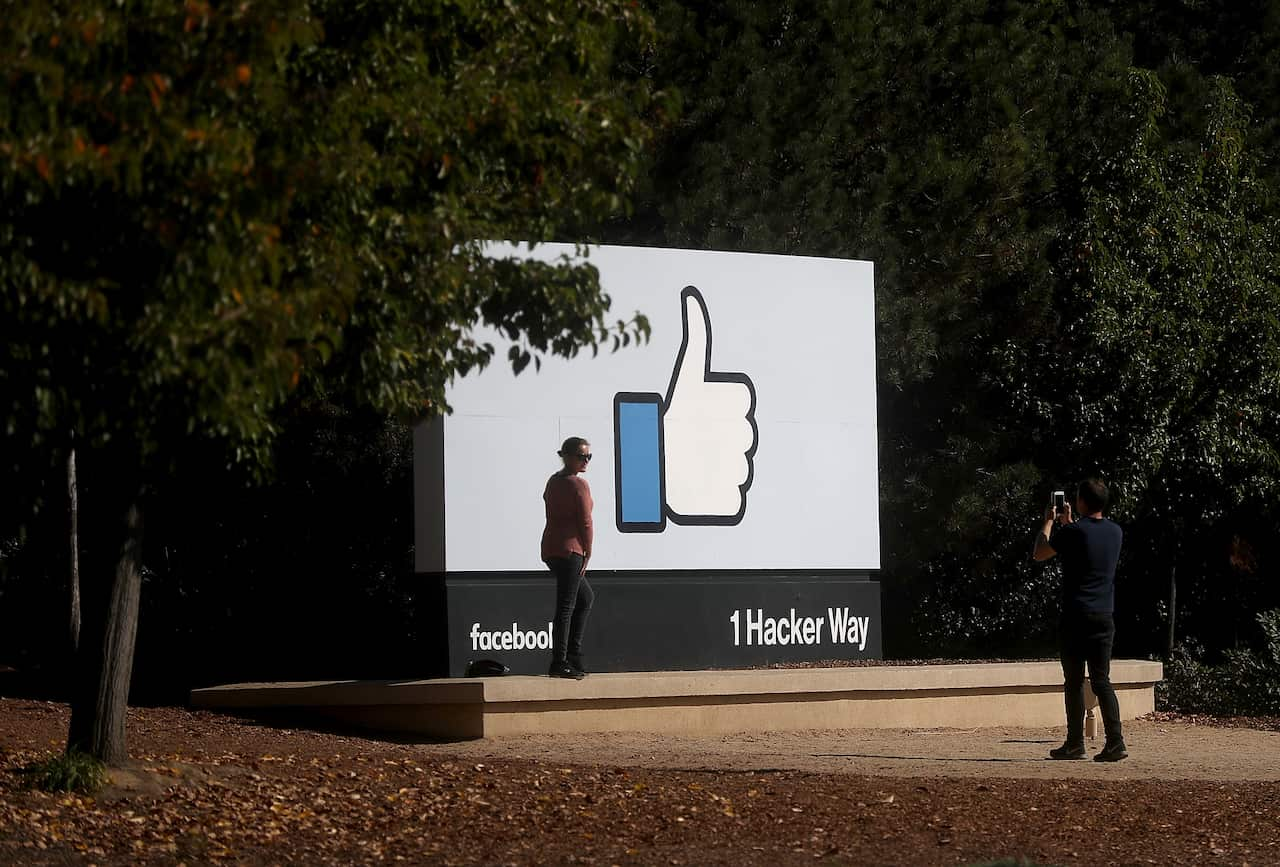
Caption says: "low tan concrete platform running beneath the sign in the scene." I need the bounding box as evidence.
[191,660,1164,738]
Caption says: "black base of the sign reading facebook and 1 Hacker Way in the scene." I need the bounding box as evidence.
[434,572,882,676]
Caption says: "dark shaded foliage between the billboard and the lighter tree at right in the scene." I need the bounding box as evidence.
[619,0,1130,651]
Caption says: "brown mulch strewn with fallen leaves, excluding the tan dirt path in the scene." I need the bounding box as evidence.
[0,699,1280,866]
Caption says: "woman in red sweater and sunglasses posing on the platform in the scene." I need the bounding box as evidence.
[543,437,595,680]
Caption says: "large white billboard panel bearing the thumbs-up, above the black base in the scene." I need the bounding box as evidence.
[415,245,879,572]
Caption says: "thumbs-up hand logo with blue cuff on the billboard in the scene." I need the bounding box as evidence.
[613,286,758,533]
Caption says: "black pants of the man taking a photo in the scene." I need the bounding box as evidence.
[1061,613,1124,744]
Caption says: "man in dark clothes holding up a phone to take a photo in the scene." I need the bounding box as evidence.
[1033,479,1129,762]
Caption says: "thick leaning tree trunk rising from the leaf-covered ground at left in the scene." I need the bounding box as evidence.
[67,497,142,766]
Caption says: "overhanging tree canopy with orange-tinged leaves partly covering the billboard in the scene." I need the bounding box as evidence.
[0,0,660,494]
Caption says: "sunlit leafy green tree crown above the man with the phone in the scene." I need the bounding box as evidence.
[1004,72,1280,525]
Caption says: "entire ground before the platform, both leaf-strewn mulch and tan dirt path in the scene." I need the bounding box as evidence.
[0,698,1280,866]
